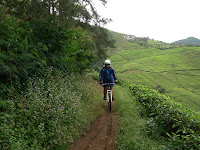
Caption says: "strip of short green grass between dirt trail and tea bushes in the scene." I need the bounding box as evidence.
[114,85,167,150]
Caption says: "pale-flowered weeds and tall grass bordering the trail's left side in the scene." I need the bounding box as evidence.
[0,68,103,149]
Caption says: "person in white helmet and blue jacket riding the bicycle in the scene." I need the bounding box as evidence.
[99,60,117,100]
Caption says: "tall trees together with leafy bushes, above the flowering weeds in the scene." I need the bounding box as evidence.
[0,0,114,99]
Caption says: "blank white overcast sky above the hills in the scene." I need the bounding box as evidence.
[95,0,200,43]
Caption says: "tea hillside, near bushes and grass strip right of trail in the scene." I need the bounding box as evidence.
[109,30,200,150]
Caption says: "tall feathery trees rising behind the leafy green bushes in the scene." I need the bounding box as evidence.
[0,0,114,57]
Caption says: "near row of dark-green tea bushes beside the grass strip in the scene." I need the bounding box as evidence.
[121,81,200,149]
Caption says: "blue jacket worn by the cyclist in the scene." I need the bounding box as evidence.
[99,66,117,81]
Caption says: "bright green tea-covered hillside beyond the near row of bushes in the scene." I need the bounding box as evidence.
[110,33,200,111]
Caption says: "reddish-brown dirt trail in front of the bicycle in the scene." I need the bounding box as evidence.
[69,82,119,150]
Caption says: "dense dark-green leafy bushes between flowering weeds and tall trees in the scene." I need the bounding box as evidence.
[0,9,95,100]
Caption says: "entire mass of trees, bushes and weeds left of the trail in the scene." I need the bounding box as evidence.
[0,0,112,149]
